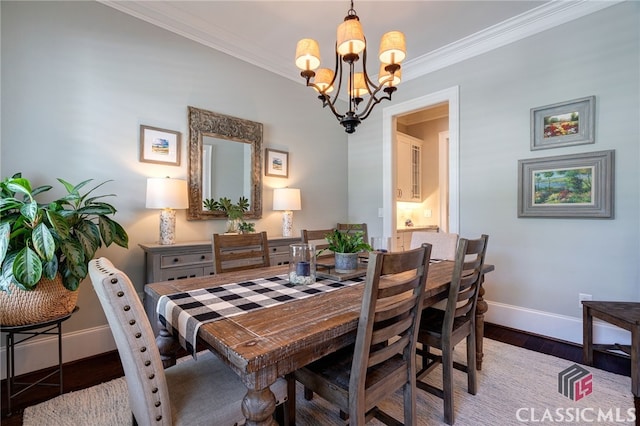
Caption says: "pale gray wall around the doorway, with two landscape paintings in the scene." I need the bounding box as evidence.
[349,2,640,337]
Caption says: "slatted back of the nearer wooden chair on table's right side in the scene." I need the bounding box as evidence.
[349,244,431,404]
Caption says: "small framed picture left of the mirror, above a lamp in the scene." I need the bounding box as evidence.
[140,126,180,166]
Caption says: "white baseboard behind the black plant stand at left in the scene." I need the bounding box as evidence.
[0,325,116,380]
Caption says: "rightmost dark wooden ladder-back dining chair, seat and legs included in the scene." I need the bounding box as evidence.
[416,235,489,425]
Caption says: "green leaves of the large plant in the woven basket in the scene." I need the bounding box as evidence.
[0,173,129,291]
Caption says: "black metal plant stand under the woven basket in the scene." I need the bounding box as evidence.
[0,306,80,416]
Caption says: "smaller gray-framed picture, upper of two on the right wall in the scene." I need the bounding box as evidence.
[531,96,596,151]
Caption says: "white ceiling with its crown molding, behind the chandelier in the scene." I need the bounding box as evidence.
[98,0,619,84]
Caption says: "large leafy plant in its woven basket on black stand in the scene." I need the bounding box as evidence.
[0,173,129,325]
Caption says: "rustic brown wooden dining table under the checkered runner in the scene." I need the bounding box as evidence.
[145,261,494,426]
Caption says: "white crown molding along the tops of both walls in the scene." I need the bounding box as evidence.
[98,0,625,84]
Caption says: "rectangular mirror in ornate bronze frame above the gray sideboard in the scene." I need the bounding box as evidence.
[187,107,262,220]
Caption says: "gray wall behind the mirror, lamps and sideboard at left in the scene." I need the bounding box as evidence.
[0,1,347,342]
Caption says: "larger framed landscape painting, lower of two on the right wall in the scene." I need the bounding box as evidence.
[518,150,614,218]
